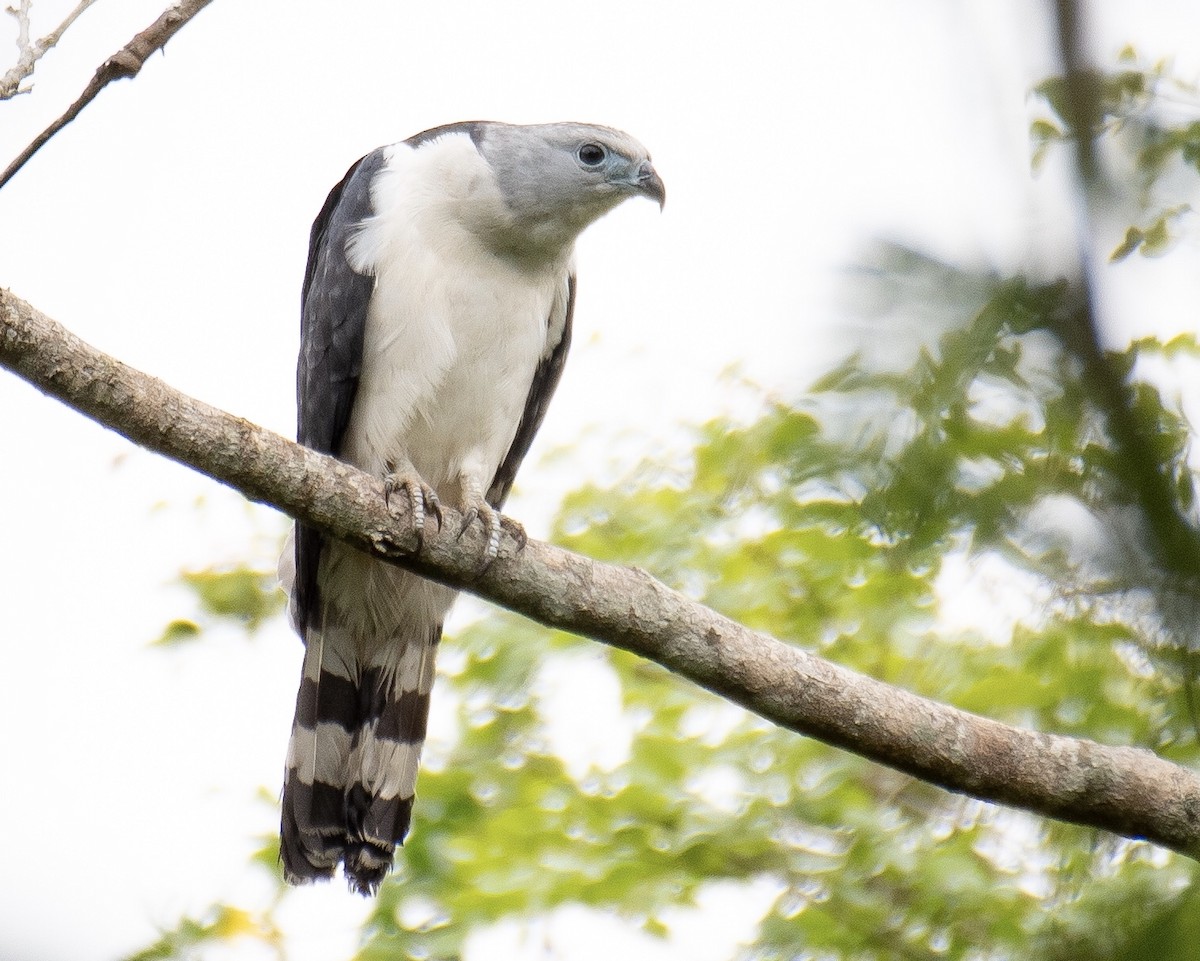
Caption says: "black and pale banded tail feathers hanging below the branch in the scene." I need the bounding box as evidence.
[280,626,442,894]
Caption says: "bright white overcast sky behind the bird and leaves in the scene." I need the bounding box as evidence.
[0,0,1200,961]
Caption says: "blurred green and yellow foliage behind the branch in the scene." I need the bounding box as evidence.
[129,52,1200,961]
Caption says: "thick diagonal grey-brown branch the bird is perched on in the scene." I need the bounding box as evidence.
[7,290,1200,858]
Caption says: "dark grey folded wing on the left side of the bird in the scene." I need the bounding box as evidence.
[293,149,384,635]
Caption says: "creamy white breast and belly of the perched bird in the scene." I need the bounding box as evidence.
[342,134,566,494]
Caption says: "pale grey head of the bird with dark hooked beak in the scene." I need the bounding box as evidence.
[472,124,666,263]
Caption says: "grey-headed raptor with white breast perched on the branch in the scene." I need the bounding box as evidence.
[280,121,666,895]
